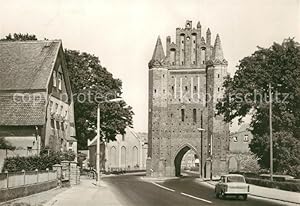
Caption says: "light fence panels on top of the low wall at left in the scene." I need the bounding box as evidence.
[0,170,57,189]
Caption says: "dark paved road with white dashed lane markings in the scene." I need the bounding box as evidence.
[103,176,286,206]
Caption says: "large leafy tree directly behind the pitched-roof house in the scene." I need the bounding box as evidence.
[65,50,133,149]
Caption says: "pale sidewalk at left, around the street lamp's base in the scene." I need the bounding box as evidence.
[44,178,122,206]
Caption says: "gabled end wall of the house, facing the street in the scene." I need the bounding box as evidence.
[45,51,75,151]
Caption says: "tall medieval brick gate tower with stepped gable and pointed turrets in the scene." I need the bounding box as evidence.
[147,21,229,178]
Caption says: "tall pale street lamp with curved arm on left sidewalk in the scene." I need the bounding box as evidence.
[96,98,123,186]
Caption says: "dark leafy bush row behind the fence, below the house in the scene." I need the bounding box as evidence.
[2,151,75,172]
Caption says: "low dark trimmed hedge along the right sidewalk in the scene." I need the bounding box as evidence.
[246,177,300,192]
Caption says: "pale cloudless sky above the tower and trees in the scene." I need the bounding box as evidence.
[0,0,300,132]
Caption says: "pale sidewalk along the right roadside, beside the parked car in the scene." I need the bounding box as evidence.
[197,180,300,205]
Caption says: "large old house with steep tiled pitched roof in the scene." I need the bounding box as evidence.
[0,40,76,154]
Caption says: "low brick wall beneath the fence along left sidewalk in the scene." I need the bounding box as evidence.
[0,180,57,202]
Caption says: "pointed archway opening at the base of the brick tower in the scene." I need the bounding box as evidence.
[174,146,200,177]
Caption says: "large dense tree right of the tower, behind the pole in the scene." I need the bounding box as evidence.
[217,39,300,175]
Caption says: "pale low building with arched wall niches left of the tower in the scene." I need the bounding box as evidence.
[88,128,148,171]
